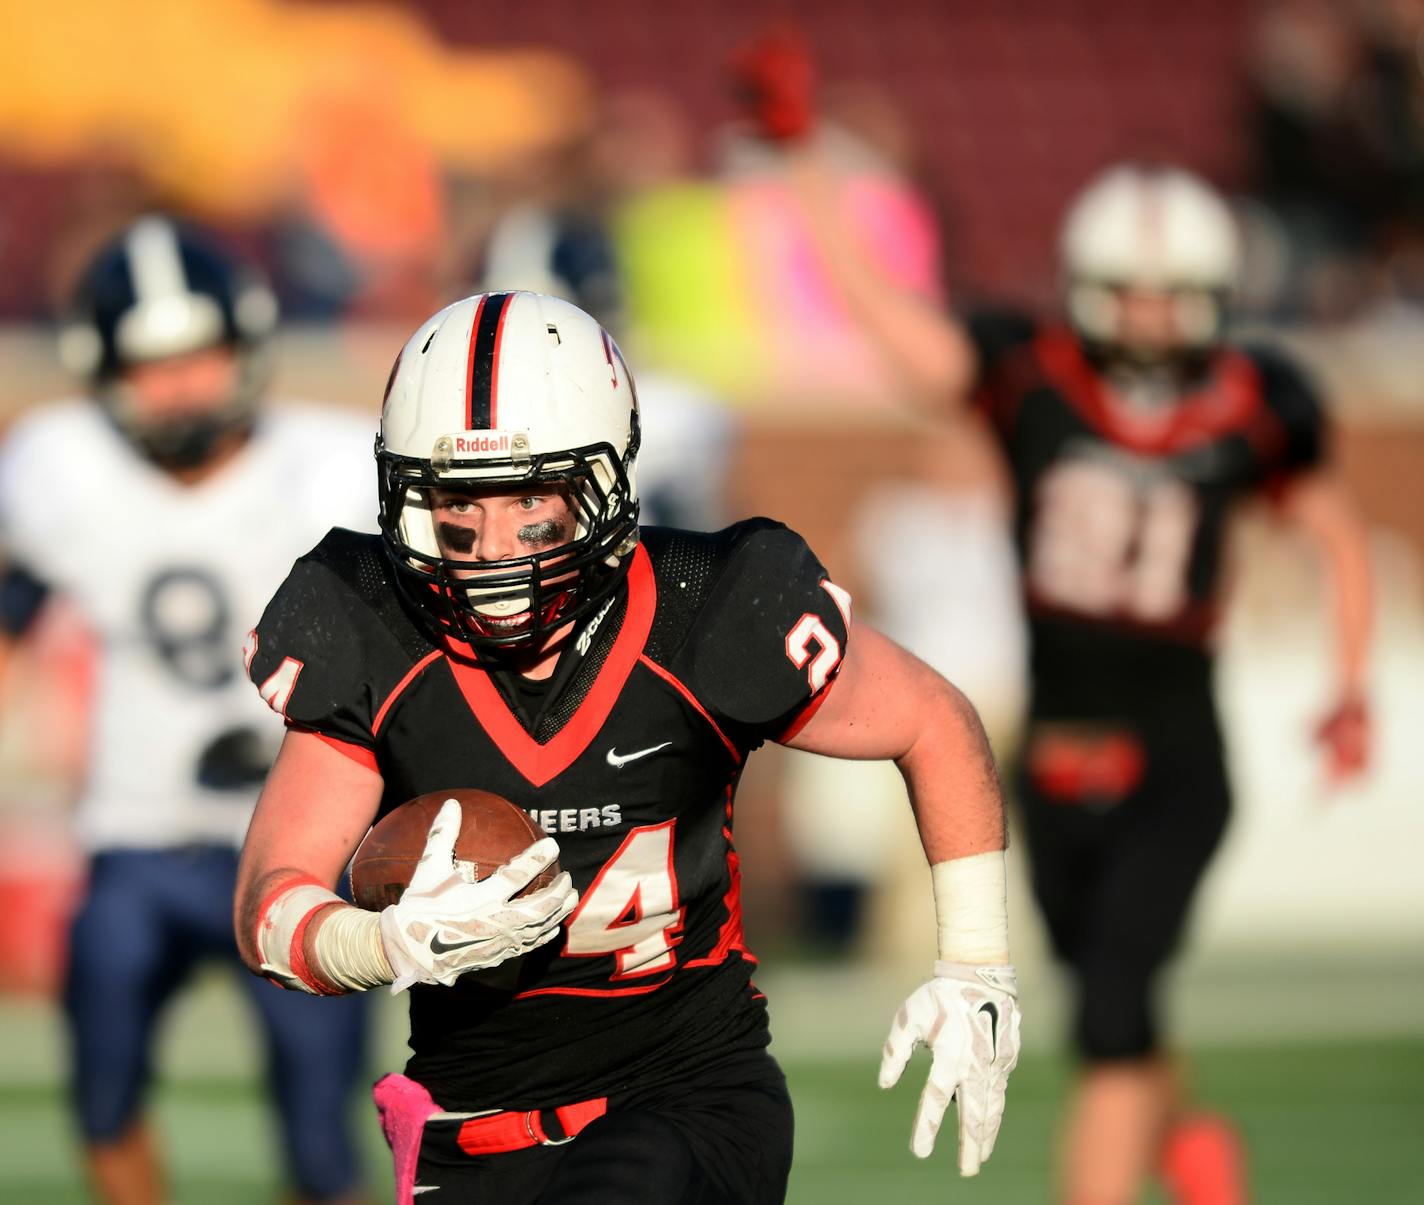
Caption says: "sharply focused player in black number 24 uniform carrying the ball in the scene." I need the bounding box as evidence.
[236,292,1018,1205]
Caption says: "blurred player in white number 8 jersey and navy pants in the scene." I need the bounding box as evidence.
[0,217,375,1205]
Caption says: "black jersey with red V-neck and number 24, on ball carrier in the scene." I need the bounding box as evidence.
[251,520,849,1111]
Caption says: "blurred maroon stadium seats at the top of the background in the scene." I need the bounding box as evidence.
[0,0,1252,318]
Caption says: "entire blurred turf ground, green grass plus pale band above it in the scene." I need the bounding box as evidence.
[0,951,1424,1205]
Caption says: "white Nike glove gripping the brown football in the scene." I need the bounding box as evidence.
[380,799,578,993]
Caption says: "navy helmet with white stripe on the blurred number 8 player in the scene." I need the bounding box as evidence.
[60,217,278,467]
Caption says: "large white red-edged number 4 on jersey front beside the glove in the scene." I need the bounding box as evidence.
[564,820,684,979]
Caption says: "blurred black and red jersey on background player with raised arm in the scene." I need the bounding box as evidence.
[970,313,1324,718]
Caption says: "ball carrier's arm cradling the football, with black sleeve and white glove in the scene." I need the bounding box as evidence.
[234,533,577,996]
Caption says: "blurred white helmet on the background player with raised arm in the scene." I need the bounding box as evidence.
[1058,165,1240,359]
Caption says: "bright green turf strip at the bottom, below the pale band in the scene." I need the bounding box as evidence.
[0,1040,1424,1205]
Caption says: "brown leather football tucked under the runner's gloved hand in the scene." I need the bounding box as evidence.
[350,791,558,912]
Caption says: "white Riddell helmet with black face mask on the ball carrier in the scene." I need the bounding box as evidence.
[376,292,639,647]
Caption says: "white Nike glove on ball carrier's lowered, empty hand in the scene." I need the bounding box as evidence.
[880,963,1018,1175]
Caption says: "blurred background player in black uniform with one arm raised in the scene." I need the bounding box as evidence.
[790,158,1371,1205]
